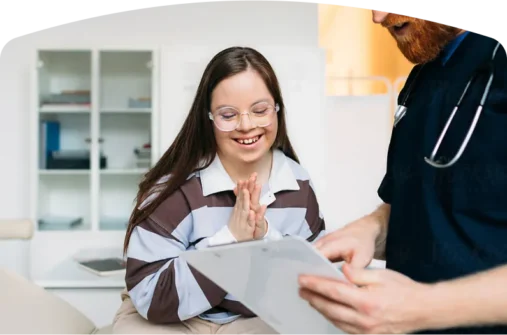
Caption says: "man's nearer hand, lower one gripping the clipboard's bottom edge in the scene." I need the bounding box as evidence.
[300,264,431,335]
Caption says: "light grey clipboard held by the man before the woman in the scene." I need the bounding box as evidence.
[180,236,352,335]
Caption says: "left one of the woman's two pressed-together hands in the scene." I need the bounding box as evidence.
[228,181,255,242]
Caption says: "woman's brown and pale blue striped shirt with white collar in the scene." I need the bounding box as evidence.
[126,150,325,324]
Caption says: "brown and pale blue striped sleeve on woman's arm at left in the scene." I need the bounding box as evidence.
[126,190,226,323]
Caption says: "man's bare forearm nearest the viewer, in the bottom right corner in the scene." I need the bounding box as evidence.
[421,265,507,329]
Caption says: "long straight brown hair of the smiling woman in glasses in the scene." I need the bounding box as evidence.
[124,47,299,253]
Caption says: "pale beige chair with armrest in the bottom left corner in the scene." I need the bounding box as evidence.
[0,220,112,335]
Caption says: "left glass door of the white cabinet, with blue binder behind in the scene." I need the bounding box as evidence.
[36,50,92,231]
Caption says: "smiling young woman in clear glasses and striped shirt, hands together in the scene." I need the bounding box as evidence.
[114,47,325,335]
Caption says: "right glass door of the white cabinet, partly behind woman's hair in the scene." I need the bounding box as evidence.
[98,51,153,230]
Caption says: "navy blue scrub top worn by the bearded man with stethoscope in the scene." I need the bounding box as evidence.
[378,31,507,335]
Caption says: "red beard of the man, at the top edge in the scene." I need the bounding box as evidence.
[382,12,461,64]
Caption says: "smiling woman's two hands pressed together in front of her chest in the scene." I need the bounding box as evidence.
[229,173,268,242]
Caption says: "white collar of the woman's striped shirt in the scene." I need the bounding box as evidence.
[199,149,299,197]
